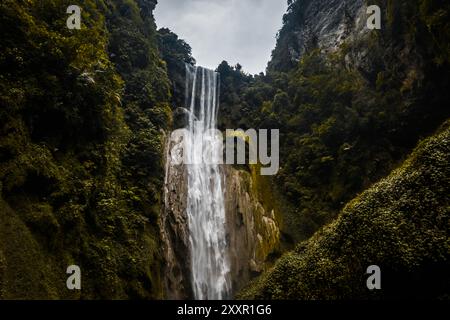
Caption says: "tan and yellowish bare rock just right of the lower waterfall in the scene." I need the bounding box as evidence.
[224,166,280,292]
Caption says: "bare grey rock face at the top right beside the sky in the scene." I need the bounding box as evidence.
[268,0,367,71]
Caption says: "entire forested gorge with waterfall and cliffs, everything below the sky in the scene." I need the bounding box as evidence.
[0,0,450,300]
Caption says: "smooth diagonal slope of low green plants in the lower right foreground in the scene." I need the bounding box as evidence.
[239,122,450,299]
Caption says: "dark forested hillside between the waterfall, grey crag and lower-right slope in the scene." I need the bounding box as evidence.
[218,1,450,243]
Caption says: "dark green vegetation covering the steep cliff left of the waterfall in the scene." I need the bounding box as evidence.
[0,0,171,299]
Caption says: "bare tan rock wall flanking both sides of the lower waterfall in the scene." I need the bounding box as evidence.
[159,132,280,299]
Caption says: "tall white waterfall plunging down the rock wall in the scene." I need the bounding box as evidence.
[185,65,231,299]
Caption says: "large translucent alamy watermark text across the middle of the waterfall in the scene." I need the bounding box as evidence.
[170,129,280,176]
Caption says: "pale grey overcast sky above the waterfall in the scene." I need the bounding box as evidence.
[155,0,287,74]
